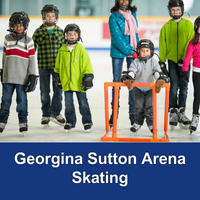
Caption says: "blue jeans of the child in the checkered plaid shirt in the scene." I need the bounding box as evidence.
[39,69,62,117]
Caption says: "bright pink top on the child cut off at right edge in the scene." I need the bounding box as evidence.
[183,40,200,72]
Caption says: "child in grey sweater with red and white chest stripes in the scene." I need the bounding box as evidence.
[0,12,37,136]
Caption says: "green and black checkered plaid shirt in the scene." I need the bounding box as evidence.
[33,24,64,69]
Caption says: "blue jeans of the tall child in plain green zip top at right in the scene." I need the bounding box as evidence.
[168,60,190,109]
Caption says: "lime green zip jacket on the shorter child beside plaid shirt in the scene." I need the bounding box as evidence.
[54,43,93,92]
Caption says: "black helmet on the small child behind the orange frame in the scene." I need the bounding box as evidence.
[136,39,154,60]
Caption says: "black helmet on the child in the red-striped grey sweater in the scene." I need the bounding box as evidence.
[8,11,30,34]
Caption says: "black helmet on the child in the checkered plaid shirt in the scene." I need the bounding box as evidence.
[41,4,59,26]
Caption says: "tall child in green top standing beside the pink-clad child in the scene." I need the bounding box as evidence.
[159,0,194,130]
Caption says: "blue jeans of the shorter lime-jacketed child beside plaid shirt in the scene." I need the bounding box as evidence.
[64,91,92,127]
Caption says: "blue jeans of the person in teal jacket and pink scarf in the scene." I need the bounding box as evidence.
[111,58,135,114]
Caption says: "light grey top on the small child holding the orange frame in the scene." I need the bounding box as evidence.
[129,58,162,90]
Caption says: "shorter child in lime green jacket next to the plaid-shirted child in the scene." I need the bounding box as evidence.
[54,24,93,132]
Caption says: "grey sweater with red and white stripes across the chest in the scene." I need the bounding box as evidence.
[2,33,36,85]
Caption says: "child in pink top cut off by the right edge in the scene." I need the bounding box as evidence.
[181,16,200,133]
